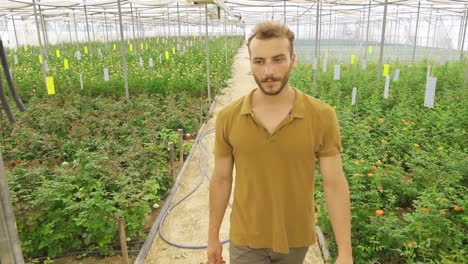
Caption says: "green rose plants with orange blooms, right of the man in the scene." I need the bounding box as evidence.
[292,58,468,263]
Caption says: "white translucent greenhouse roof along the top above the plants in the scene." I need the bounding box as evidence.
[0,0,468,24]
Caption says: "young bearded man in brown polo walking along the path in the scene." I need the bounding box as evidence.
[208,22,353,264]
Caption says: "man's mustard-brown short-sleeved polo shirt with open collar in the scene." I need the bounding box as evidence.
[214,88,341,253]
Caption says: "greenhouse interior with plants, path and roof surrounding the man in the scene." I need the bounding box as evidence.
[0,0,468,264]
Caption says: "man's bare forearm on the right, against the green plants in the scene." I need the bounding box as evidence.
[323,176,352,256]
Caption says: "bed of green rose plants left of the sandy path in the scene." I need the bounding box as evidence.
[1,37,241,260]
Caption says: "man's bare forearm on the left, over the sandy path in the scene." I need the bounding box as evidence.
[208,177,232,240]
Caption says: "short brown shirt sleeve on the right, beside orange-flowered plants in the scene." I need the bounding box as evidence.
[317,108,341,157]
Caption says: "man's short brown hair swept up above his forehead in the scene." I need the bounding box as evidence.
[247,21,294,54]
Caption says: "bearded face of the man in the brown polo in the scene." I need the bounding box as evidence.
[250,38,296,96]
